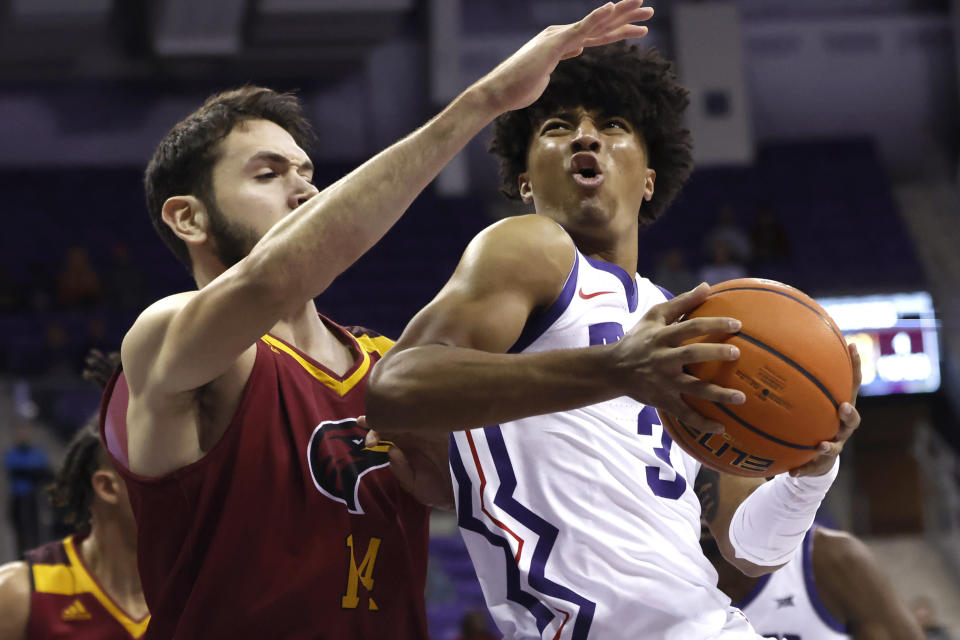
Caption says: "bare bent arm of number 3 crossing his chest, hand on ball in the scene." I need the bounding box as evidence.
[367,215,736,437]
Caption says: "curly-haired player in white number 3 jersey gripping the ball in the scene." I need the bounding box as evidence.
[367,45,859,640]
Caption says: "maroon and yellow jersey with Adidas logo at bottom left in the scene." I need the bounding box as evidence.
[24,536,150,640]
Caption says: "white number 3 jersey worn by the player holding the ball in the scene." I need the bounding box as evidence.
[450,252,759,640]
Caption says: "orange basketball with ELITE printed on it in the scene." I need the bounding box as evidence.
[660,278,853,476]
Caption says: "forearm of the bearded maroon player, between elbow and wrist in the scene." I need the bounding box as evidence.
[251,86,499,300]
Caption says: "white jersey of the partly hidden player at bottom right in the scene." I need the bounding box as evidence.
[737,529,850,640]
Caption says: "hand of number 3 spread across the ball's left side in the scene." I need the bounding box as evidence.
[614,283,746,433]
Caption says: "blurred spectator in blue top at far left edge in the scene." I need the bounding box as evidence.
[3,420,52,555]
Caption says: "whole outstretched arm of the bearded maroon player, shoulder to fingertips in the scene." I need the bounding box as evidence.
[123,0,653,395]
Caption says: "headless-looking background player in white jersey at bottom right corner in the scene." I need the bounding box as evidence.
[700,526,923,640]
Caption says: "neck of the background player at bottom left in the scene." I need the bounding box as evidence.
[77,514,147,619]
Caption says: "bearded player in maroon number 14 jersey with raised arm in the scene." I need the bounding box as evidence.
[101,0,668,640]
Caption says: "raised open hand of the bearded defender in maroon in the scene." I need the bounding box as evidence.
[475,0,653,114]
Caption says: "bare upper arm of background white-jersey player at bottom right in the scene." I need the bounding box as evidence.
[813,527,923,640]
